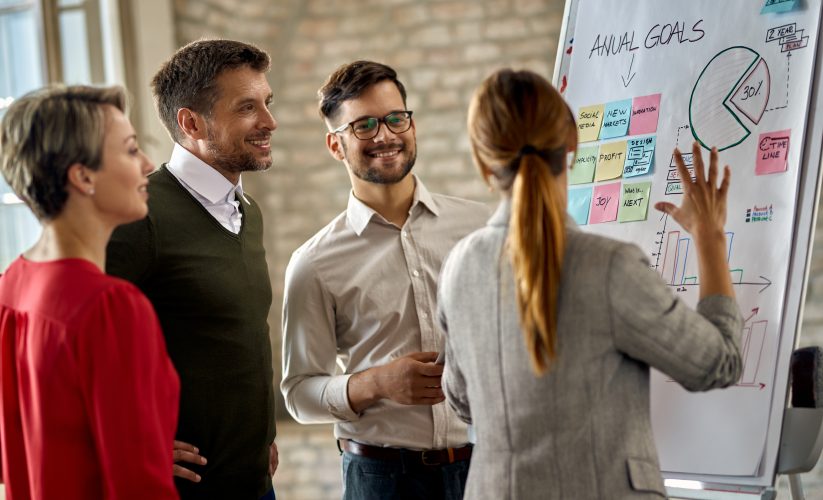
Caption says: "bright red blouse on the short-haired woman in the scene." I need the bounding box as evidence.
[0,257,180,500]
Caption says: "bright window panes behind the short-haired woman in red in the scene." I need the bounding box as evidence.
[0,0,123,272]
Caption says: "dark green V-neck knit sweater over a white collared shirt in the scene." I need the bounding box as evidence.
[106,165,275,500]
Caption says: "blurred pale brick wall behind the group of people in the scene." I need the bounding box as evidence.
[167,0,823,500]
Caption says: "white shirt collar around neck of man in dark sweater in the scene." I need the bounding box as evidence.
[166,144,249,203]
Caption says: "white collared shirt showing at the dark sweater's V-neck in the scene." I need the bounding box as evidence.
[166,144,248,234]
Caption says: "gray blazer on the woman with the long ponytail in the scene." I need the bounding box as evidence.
[438,202,743,500]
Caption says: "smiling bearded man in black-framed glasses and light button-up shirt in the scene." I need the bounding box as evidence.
[281,61,488,499]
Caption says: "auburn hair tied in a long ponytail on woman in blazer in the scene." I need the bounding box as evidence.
[468,69,577,375]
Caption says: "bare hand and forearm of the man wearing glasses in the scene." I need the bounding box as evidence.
[348,352,446,413]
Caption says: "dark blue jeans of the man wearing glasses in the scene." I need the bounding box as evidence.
[343,452,469,500]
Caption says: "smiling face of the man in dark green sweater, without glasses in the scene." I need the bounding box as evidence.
[202,66,277,177]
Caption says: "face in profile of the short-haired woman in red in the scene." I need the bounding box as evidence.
[91,105,154,225]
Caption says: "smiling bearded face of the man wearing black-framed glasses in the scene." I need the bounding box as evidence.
[326,80,417,184]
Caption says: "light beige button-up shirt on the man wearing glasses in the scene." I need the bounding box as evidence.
[280,178,489,450]
